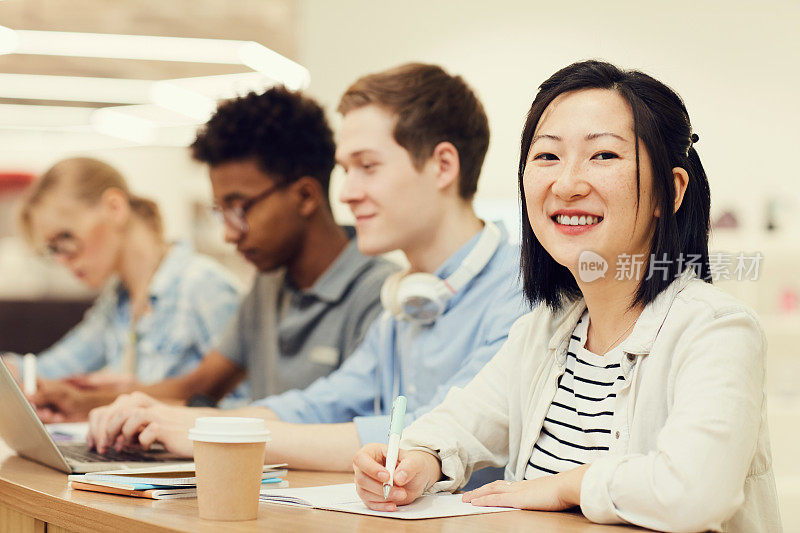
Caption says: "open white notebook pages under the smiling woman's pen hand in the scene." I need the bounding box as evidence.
[261,483,517,520]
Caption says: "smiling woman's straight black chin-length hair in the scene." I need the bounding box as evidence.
[518,60,711,310]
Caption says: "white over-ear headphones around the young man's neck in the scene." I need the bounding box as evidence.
[381,222,503,324]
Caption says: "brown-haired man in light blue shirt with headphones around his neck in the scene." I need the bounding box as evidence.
[84,64,527,476]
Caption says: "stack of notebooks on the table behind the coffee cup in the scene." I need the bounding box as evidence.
[69,463,289,500]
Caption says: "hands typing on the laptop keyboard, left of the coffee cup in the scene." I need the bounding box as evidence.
[87,392,197,457]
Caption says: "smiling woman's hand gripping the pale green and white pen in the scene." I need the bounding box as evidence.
[353,443,442,511]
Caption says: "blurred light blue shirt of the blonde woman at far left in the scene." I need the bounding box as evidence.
[30,243,239,383]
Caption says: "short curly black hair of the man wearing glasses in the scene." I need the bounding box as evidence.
[191,86,336,199]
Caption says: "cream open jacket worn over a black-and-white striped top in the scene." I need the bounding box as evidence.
[402,269,781,533]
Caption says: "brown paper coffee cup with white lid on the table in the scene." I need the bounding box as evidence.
[189,416,269,521]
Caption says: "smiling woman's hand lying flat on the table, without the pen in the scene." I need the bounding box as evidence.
[462,465,589,511]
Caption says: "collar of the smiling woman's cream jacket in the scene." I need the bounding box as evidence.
[548,268,697,356]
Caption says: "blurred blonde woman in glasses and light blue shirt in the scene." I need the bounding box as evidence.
[6,157,238,418]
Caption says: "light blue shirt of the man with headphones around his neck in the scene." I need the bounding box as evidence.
[254,222,530,444]
